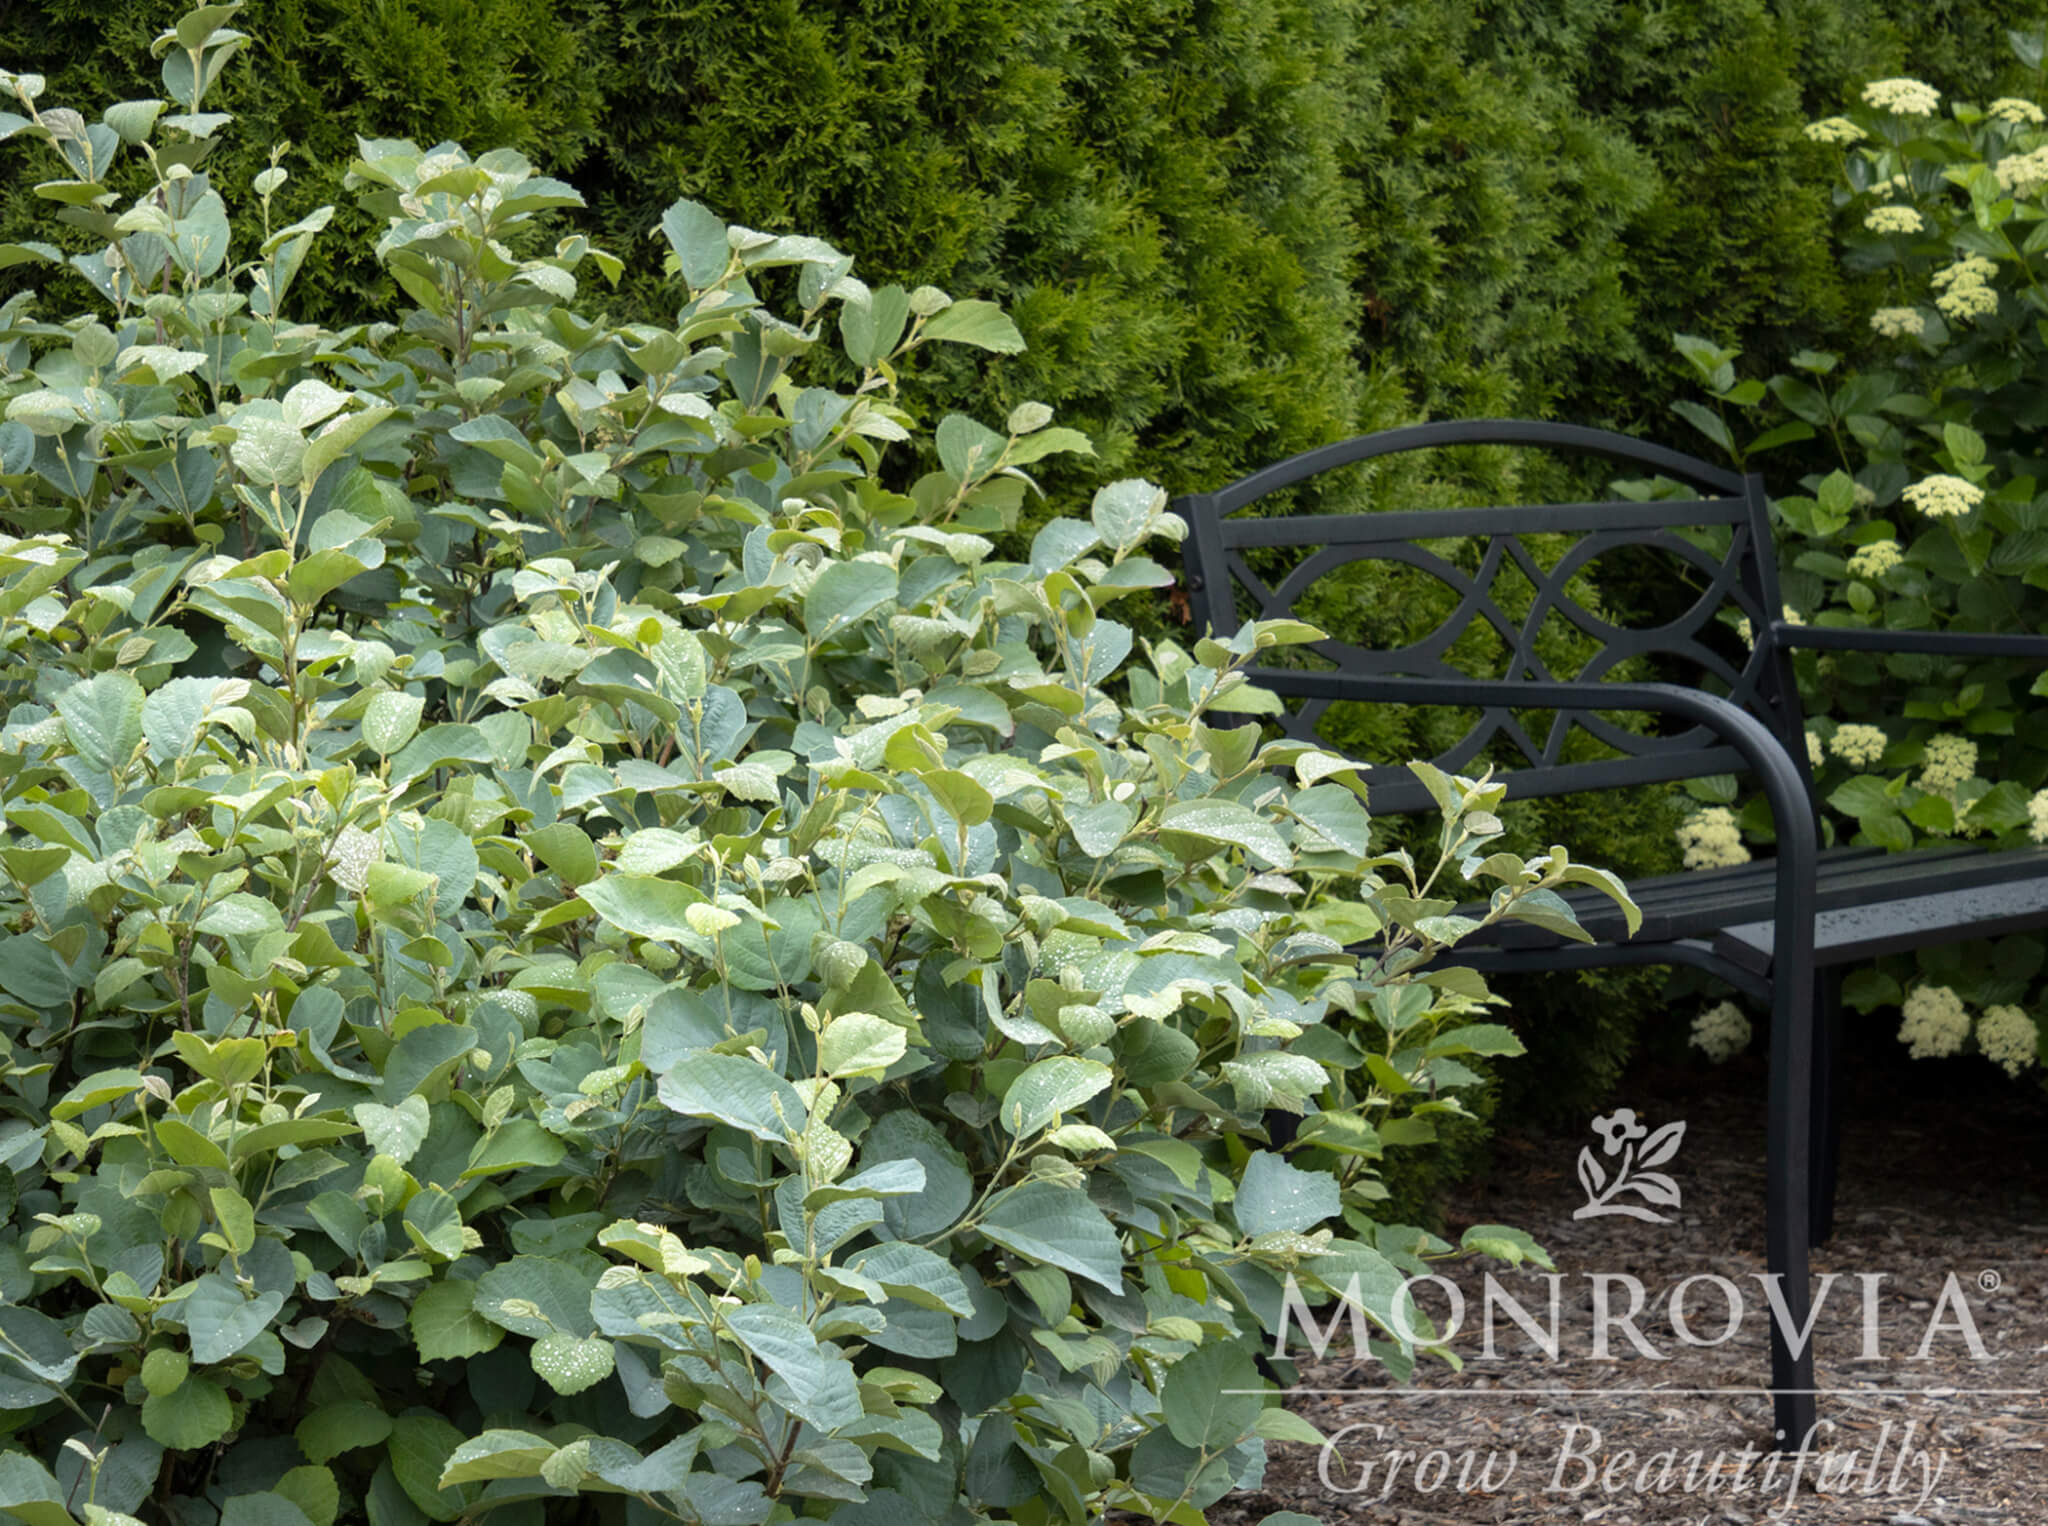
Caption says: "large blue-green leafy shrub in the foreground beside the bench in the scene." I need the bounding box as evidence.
[0,6,1620,1526]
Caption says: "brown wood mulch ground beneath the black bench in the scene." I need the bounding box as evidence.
[1210,1036,2048,1526]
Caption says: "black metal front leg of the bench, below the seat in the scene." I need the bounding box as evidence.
[1763,965,1817,1452]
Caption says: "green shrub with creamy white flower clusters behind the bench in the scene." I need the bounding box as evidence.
[1679,33,2048,1075]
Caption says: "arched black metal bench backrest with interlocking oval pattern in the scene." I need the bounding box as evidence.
[1174,420,1806,811]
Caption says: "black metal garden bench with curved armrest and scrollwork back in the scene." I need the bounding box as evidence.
[1174,420,2048,1448]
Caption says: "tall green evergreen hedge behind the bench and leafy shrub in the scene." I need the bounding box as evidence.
[0,0,2038,490]
